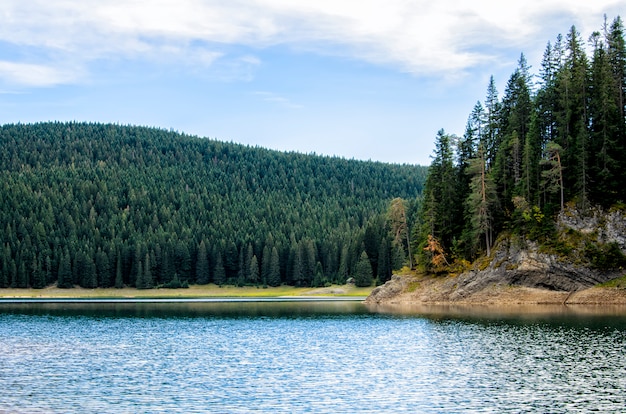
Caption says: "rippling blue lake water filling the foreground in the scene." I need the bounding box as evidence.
[0,302,626,413]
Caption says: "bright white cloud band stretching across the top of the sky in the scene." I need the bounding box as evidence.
[0,0,624,86]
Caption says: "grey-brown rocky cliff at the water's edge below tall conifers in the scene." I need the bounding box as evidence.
[368,209,626,303]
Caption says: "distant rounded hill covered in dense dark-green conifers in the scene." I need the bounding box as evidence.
[0,123,427,288]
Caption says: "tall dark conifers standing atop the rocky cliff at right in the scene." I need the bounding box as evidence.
[414,17,626,265]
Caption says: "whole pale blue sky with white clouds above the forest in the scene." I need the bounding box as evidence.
[0,0,626,165]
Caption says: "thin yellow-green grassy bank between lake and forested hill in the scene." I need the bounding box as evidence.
[0,284,373,298]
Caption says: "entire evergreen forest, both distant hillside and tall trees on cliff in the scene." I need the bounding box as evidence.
[0,17,626,289]
